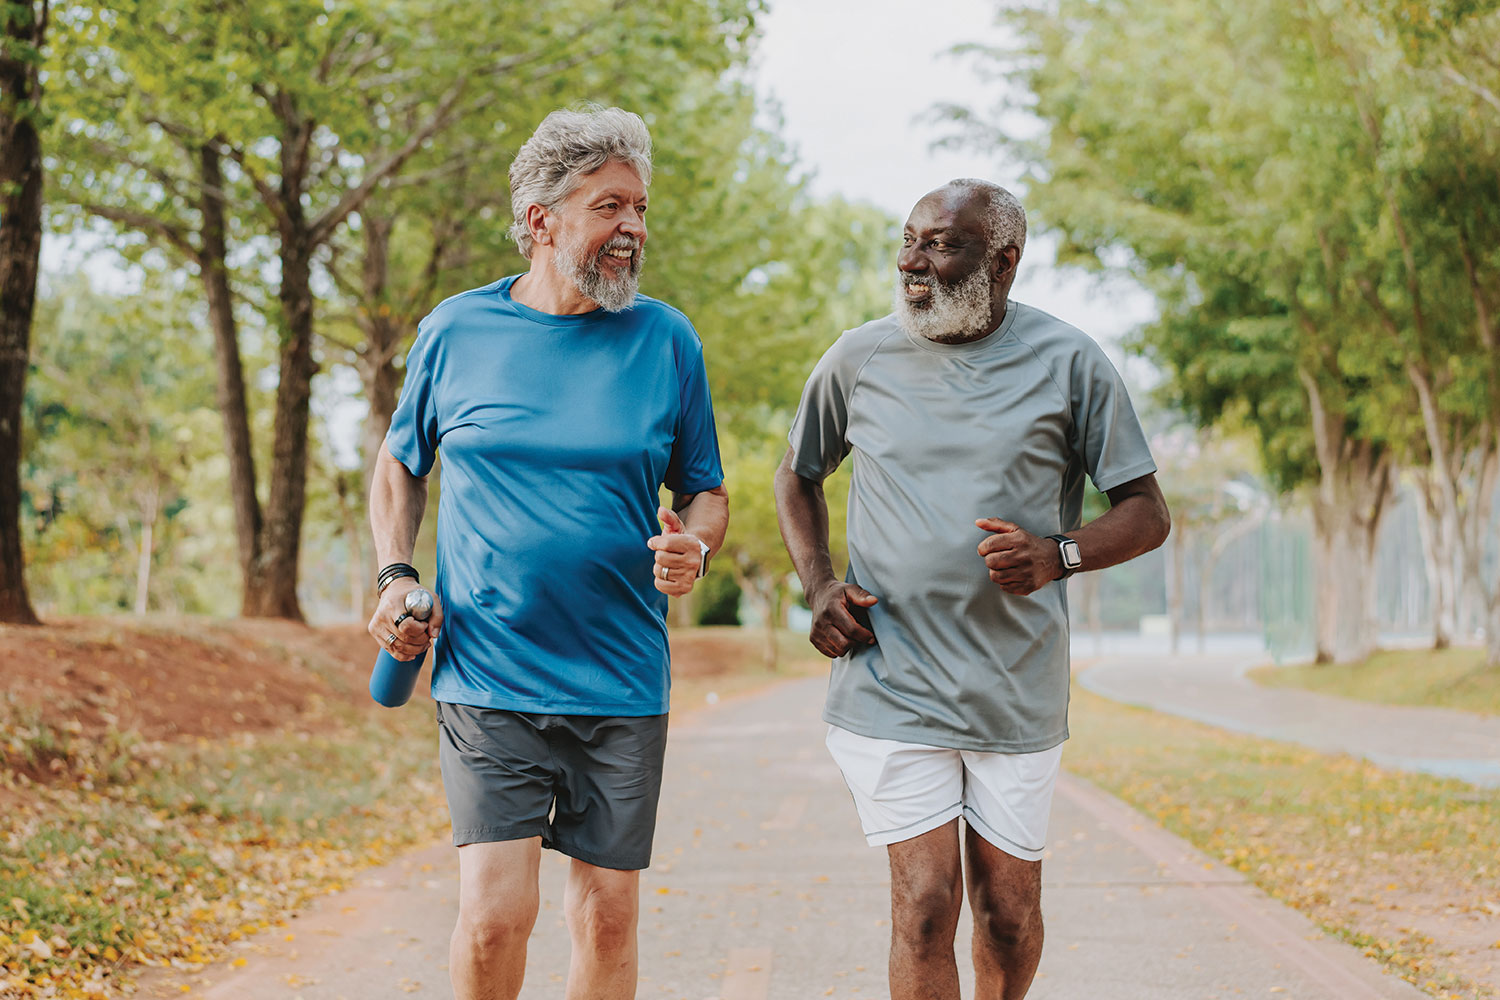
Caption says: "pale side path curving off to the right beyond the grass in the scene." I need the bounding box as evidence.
[1079,655,1500,786]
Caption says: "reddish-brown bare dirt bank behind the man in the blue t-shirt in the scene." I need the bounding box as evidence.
[0,618,804,779]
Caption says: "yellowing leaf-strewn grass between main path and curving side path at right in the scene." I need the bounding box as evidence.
[1064,688,1500,1000]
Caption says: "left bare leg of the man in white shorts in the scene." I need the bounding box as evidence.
[888,820,963,1000]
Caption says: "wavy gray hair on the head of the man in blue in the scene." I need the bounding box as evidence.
[510,103,651,259]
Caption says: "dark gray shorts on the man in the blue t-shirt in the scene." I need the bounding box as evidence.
[438,702,666,871]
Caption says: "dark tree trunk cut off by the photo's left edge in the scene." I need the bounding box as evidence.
[0,0,47,625]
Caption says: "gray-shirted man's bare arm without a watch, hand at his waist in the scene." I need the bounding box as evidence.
[776,448,876,657]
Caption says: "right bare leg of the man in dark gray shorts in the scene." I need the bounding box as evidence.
[563,858,641,1000]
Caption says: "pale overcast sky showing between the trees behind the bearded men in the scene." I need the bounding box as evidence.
[756,0,1154,358]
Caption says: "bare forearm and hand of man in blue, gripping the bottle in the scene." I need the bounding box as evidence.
[369,444,443,660]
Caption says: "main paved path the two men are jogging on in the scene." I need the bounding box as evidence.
[141,679,1422,1000]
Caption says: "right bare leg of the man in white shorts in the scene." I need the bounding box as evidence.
[965,826,1043,1000]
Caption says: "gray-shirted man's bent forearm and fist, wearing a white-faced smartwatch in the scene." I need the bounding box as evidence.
[975,474,1172,595]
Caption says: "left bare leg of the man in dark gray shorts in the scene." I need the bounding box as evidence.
[449,837,542,1000]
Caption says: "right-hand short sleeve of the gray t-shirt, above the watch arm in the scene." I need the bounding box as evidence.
[1070,340,1157,493]
